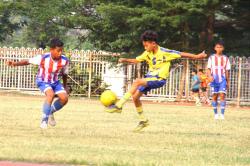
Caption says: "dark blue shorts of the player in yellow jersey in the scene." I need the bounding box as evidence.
[138,77,166,94]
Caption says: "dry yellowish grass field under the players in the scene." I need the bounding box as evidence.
[0,95,250,166]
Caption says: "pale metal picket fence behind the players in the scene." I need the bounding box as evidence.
[0,47,250,105]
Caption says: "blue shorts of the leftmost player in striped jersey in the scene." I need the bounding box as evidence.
[37,81,66,94]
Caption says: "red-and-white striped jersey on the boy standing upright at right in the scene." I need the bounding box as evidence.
[207,54,231,83]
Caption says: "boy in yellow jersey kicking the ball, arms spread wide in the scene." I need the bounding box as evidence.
[107,30,206,131]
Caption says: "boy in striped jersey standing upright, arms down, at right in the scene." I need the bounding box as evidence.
[207,42,231,119]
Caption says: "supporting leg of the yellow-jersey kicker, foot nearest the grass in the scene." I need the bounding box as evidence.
[132,90,149,132]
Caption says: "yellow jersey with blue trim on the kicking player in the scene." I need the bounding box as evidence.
[136,46,181,79]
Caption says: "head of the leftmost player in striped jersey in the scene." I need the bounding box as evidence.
[50,38,63,60]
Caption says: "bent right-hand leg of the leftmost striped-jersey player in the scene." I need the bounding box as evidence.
[49,82,68,126]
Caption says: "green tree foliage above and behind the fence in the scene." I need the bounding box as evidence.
[0,0,250,56]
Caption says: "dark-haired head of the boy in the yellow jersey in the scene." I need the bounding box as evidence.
[141,30,158,52]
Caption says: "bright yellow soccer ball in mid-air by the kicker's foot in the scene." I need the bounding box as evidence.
[100,90,117,107]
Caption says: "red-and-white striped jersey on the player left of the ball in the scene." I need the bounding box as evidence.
[29,53,69,83]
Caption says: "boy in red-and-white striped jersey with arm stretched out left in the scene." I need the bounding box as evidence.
[7,38,69,129]
